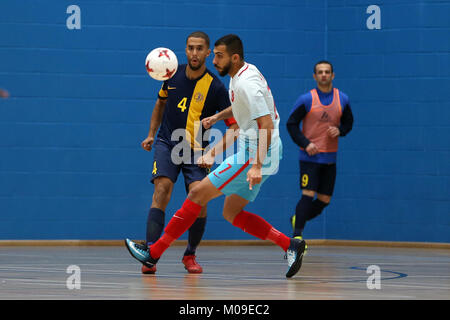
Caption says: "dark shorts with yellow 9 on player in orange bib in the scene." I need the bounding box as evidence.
[300,161,336,196]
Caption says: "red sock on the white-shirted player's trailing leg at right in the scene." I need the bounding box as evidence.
[233,211,291,251]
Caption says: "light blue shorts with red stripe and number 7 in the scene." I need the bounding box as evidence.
[208,144,281,201]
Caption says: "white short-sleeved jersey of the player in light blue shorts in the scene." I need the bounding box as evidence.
[229,63,281,152]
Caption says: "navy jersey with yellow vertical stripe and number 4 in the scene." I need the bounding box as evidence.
[158,64,232,150]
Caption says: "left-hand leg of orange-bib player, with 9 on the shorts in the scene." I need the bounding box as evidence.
[293,161,320,237]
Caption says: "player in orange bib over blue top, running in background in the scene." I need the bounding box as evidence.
[287,61,353,239]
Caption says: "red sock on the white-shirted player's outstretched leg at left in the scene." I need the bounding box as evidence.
[150,199,202,259]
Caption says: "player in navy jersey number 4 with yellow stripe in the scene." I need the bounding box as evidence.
[136,31,236,273]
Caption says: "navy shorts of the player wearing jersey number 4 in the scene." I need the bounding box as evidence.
[151,139,209,190]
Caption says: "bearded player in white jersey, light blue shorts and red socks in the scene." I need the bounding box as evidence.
[125,34,305,278]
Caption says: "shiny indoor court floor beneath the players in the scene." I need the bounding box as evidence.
[0,245,450,300]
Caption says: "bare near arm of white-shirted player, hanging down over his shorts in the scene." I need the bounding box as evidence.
[247,114,274,190]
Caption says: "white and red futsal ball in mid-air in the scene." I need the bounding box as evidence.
[145,48,178,81]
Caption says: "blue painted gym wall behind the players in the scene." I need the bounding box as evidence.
[0,0,450,242]
